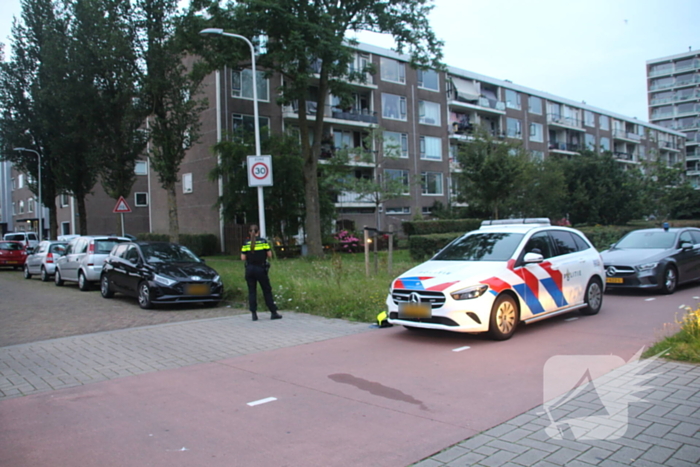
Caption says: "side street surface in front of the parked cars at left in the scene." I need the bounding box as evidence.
[0,269,248,347]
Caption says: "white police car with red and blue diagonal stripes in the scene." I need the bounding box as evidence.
[386,218,605,340]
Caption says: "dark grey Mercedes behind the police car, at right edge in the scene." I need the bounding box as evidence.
[601,227,700,294]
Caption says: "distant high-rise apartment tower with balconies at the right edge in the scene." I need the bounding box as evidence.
[647,50,700,189]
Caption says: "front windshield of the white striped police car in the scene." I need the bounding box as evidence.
[433,232,523,261]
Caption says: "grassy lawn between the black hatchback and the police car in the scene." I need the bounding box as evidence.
[206,250,416,322]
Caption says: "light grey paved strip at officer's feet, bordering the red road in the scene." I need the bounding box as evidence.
[0,312,371,401]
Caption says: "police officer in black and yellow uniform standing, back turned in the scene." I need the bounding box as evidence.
[241,225,282,321]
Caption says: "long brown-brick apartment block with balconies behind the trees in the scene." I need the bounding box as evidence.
[0,44,685,251]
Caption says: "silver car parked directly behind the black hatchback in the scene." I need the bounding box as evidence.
[54,235,129,291]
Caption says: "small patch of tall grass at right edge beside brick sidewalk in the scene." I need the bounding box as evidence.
[643,306,700,363]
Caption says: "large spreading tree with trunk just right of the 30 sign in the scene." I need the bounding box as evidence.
[192,0,442,256]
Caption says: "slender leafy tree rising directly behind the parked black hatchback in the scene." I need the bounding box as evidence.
[136,0,206,243]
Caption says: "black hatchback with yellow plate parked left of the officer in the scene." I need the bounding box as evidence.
[100,241,224,308]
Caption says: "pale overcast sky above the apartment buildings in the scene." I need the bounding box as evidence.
[0,0,700,120]
